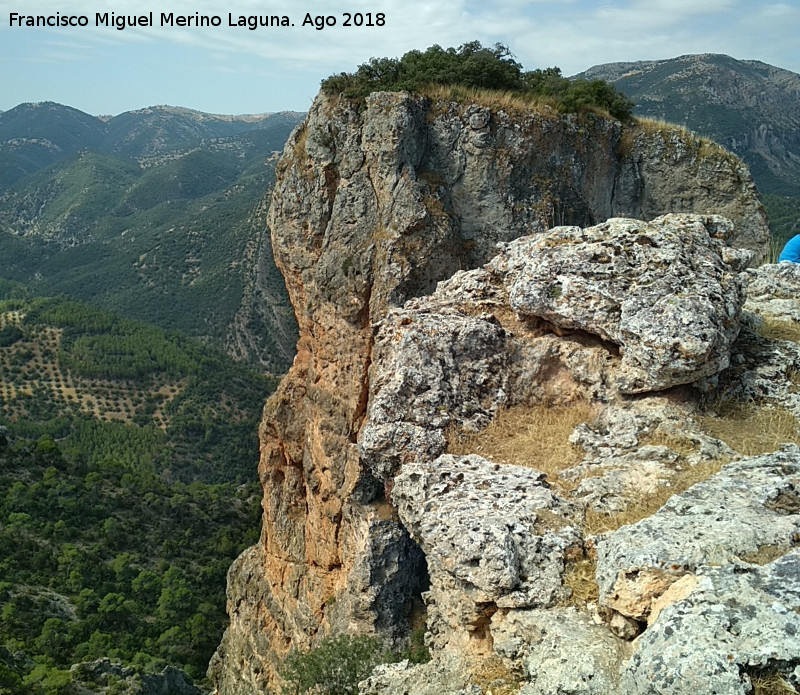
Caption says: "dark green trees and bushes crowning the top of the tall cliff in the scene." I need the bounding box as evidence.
[322,41,633,120]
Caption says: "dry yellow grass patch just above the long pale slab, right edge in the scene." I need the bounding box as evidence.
[699,401,800,456]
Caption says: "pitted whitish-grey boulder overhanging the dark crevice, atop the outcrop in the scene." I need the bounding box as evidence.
[489,215,744,393]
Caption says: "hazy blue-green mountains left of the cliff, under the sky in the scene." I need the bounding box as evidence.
[0,102,303,372]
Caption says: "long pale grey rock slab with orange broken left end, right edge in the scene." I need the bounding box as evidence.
[596,445,800,620]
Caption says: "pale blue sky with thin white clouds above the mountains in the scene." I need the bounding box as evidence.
[0,0,800,115]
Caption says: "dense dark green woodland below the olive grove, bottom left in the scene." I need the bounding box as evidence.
[0,426,258,695]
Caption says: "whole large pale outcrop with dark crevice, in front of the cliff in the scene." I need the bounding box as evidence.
[359,215,744,492]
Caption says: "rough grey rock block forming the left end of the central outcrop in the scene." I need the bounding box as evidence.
[359,309,509,479]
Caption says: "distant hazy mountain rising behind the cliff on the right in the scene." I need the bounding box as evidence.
[578,54,800,238]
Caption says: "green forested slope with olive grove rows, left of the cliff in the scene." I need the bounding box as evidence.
[0,283,274,695]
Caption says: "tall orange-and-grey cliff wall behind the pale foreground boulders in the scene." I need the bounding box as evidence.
[210,93,768,695]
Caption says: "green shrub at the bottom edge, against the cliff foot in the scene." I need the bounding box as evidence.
[281,635,383,695]
